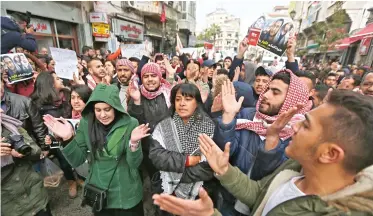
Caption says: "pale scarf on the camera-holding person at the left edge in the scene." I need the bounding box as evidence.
[0,113,22,167]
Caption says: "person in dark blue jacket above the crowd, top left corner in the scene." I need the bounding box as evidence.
[1,14,37,54]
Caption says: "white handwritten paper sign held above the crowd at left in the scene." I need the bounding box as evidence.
[49,47,79,80]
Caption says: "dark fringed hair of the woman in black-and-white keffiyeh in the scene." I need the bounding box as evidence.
[170,83,207,118]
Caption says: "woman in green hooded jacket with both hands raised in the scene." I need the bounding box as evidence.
[44,84,149,216]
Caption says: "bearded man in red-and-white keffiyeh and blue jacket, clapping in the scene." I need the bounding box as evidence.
[214,70,312,216]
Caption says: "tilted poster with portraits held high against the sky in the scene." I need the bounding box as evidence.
[248,16,295,56]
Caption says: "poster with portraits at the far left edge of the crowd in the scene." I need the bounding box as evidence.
[1,53,33,84]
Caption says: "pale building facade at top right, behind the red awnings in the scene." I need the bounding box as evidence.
[289,1,373,65]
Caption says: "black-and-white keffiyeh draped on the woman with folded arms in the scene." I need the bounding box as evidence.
[152,113,215,200]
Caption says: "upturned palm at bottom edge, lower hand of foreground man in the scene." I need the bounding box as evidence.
[153,188,214,216]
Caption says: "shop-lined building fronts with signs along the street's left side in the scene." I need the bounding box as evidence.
[1,1,196,53]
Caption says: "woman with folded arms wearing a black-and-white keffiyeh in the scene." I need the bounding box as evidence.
[149,84,215,199]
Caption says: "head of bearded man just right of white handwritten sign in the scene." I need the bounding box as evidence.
[86,59,106,91]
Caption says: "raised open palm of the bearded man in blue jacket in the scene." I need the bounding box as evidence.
[221,80,244,114]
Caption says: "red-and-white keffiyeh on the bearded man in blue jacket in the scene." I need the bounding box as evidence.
[236,69,312,140]
